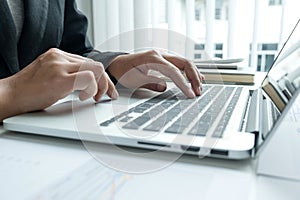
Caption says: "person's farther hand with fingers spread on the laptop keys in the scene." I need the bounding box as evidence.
[108,50,204,98]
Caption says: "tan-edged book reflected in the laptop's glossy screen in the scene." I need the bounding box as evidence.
[262,77,288,112]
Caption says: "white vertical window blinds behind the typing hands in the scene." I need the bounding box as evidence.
[91,0,292,67]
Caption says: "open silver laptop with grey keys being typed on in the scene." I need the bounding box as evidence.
[3,18,300,159]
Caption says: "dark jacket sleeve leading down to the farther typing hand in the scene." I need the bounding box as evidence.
[60,0,125,69]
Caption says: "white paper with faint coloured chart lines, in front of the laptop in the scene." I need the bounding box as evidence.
[31,159,251,200]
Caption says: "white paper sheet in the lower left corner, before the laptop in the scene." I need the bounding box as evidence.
[0,133,90,199]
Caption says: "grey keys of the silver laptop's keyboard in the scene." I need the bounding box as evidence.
[100,85,242,137]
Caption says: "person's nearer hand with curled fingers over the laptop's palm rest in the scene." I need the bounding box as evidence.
[1,49,118,119]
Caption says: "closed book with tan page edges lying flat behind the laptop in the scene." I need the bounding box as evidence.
[200,69,255,85]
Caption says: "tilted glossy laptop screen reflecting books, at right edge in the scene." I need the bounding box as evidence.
[262,19,300,112]
